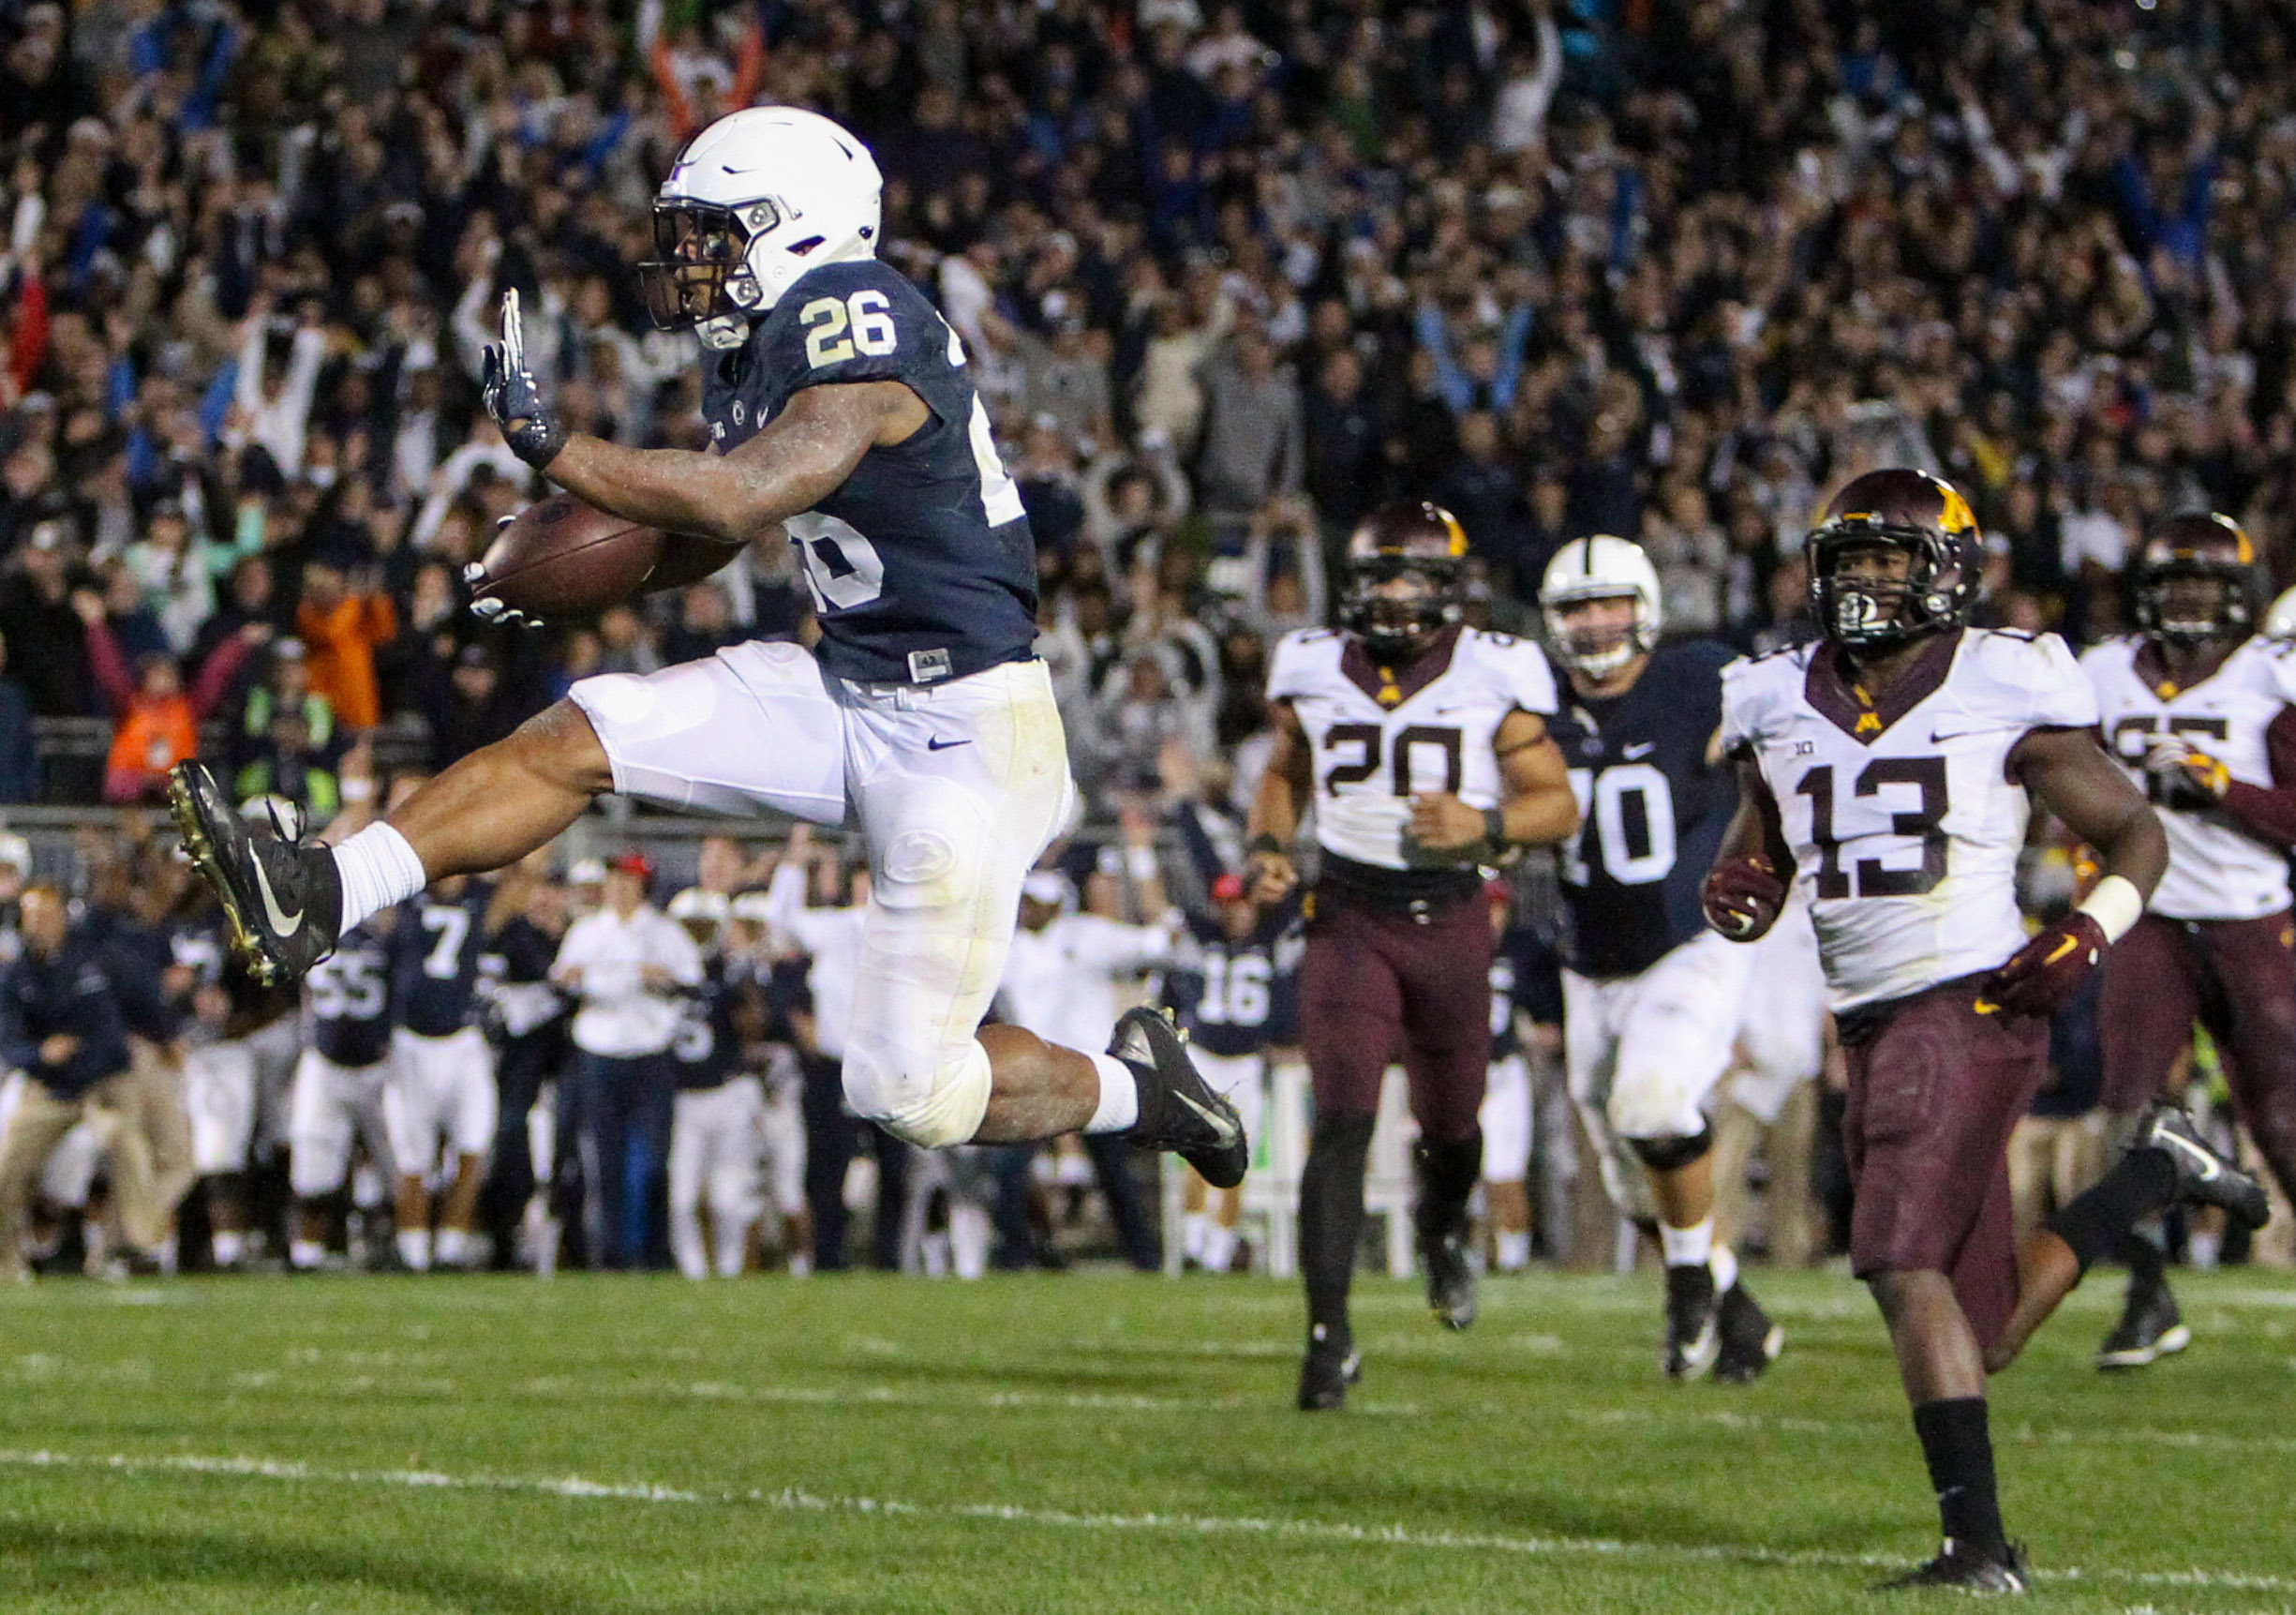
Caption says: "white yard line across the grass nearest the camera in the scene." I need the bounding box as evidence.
[0,1450,2296,1592]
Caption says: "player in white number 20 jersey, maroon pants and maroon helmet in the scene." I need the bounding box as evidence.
[1249,501,1577,1411]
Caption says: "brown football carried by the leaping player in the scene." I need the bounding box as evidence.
[475,494,739,622]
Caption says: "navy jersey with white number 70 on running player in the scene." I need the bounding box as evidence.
[1552,641,1738,979]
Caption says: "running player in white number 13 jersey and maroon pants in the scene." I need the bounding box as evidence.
[1704,471,2264,1592]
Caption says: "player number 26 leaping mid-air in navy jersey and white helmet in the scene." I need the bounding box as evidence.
[172,108,1246,1186]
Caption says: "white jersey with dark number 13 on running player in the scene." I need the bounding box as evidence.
[1722,627,2096,1009]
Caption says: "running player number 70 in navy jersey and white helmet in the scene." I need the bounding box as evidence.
[1539,533,1784,1383]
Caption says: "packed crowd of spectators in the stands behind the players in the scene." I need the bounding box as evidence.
[0,0,2296,1264]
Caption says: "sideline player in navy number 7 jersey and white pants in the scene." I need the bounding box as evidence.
[383,875,500,1273]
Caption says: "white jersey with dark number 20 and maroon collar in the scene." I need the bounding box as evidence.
[1267,627,1555,868]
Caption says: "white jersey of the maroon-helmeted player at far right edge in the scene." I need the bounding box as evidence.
[2080,636,2296,919]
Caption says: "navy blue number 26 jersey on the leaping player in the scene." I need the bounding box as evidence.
[703,260,1036,684]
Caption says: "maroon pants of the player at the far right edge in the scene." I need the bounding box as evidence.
[2098,910,2296,1194]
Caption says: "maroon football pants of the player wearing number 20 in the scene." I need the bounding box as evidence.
[1300,893,1493,1144]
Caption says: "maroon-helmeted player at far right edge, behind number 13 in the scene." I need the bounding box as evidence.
[2080,513,2296,1369]
